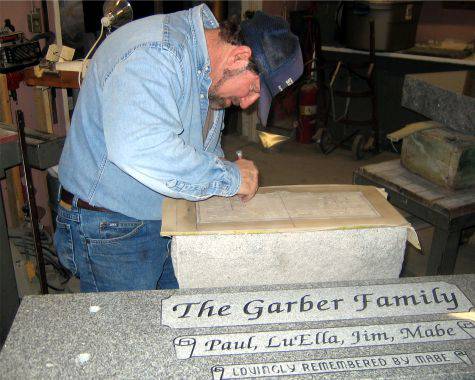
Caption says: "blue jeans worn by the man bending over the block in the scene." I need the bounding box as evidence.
[54,202,178,292]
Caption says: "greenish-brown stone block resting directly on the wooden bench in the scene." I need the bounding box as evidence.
[401,128,475,190]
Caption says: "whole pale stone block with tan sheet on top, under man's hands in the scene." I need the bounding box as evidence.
[162,185,410,288]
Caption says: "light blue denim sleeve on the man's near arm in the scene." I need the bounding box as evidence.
[102,47,241,200]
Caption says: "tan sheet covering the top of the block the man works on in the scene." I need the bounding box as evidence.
[162,185,409,236]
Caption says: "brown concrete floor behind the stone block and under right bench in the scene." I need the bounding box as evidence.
[223,135,475,277]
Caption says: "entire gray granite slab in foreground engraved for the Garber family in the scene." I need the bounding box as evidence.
[0,275,475,379]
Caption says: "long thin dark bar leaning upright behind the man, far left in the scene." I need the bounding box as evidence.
[16,110,48,294]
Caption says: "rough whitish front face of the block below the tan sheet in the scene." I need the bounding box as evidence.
[171,226,407,288]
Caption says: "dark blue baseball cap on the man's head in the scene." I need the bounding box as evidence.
[241,11,303,126]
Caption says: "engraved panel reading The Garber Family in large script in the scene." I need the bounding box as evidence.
[162,282,472,328]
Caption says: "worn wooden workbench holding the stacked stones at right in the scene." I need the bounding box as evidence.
[353,160,475,275]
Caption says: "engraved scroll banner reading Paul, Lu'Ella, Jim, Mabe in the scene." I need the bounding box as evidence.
[174,319,475,359]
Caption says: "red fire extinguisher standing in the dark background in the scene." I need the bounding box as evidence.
[297,81,318,144]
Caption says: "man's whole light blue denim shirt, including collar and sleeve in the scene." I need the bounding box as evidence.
[59,5,241,220]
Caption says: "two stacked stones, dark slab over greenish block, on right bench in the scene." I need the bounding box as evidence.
[401,71,475,190]
